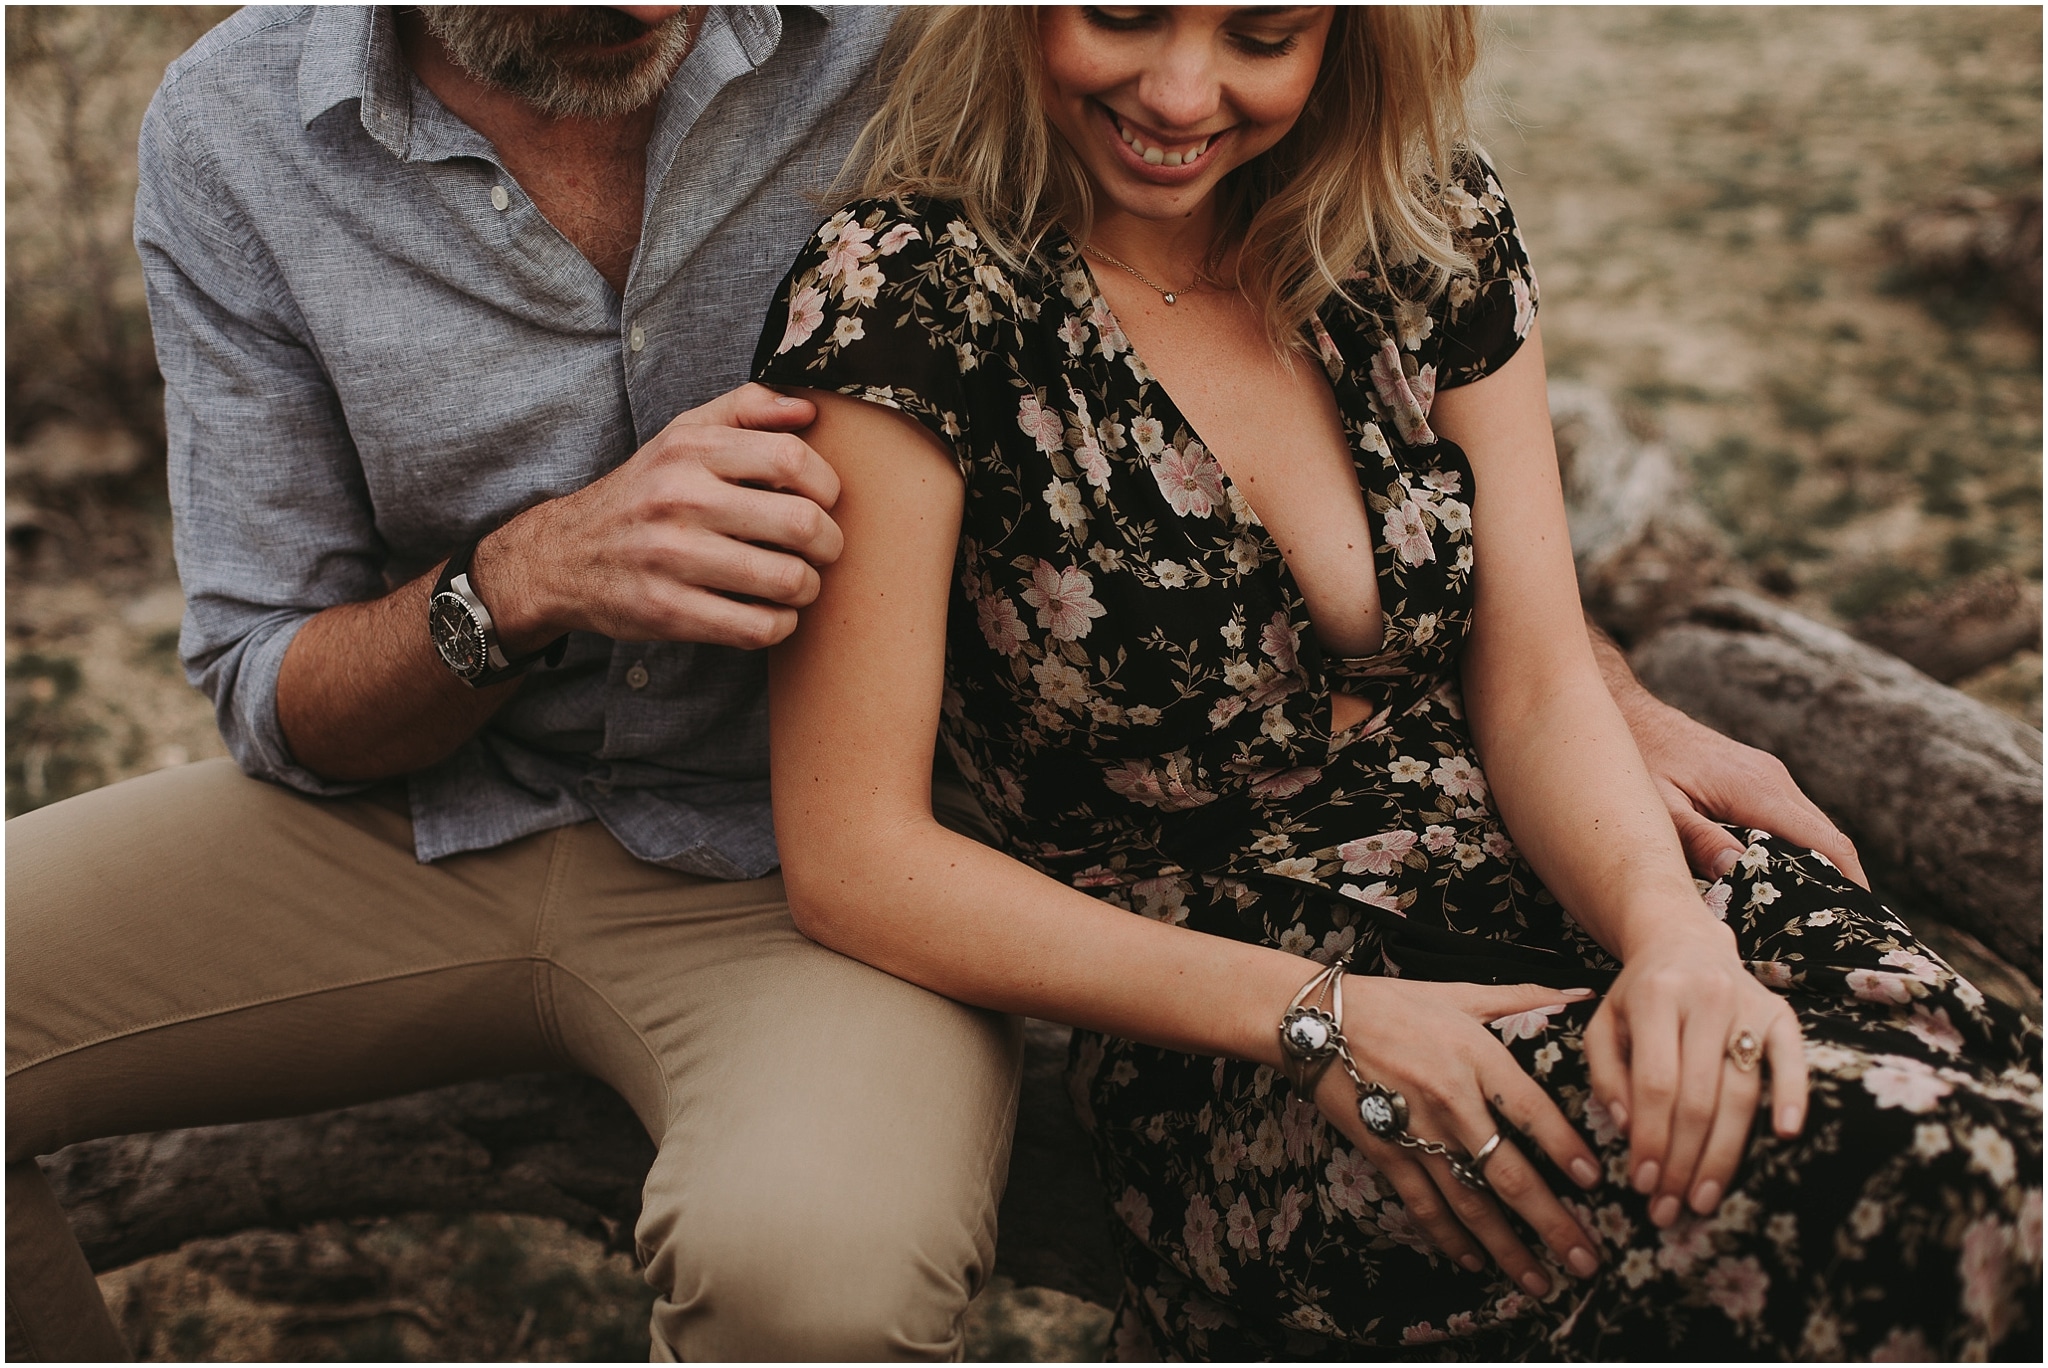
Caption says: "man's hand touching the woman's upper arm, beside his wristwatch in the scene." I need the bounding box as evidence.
[475,385,842,655]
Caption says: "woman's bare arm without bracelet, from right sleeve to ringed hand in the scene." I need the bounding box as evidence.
[1432,334,1804,1225]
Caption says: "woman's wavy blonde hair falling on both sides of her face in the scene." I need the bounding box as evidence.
[842,4,1479,350]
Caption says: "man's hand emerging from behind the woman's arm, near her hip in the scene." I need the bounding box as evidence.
[1591,629,1870,889]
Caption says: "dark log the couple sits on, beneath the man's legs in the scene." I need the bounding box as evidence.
[43,1022,1118,1305]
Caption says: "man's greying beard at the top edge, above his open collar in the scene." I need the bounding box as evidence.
[420,4,692,119]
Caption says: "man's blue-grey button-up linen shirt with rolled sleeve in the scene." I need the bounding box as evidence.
[135,6,889,879]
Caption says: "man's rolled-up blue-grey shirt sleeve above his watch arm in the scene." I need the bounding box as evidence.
[135,86,382,795]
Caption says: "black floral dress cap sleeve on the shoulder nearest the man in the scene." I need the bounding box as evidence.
[754,199,971,455]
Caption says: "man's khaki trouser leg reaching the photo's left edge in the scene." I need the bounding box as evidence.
[6,762,563,1358]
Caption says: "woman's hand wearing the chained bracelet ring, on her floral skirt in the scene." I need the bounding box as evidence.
[1315,975,1599,1296]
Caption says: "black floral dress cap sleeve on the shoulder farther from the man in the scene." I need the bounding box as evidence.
[1436,149,1536,391]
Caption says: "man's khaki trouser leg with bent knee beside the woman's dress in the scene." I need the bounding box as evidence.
[551,770,1022,1360]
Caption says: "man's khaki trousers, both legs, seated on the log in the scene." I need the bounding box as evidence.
[6,762,1020,1360]
